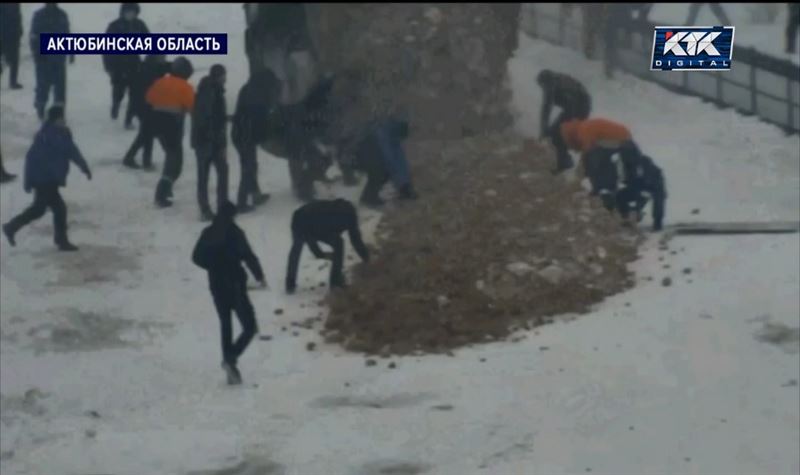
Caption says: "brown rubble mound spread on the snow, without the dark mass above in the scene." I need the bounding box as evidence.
[324,134,639,354]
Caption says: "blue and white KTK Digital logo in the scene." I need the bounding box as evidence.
[650,26,734,71]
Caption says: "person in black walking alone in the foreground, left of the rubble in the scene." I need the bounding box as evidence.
[192,201,267,384]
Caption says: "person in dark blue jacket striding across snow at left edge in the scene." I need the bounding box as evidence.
[3,106,92,251]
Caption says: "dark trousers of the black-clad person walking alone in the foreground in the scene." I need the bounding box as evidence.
[211,278,258,366]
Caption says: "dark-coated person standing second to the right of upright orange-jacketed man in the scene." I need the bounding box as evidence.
[231,69,280,213]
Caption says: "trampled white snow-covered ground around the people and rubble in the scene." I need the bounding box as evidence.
[0,4,800,475]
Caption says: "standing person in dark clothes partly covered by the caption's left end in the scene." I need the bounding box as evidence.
[30,3,75,119]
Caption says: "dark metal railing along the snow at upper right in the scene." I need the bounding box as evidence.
[522,3,800,133]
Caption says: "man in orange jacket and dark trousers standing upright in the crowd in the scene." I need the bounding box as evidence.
[145,56,194,208]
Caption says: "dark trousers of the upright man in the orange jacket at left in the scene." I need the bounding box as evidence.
[153,111,183,204]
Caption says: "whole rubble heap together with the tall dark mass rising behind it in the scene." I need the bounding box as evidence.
[316,4,640,354]
